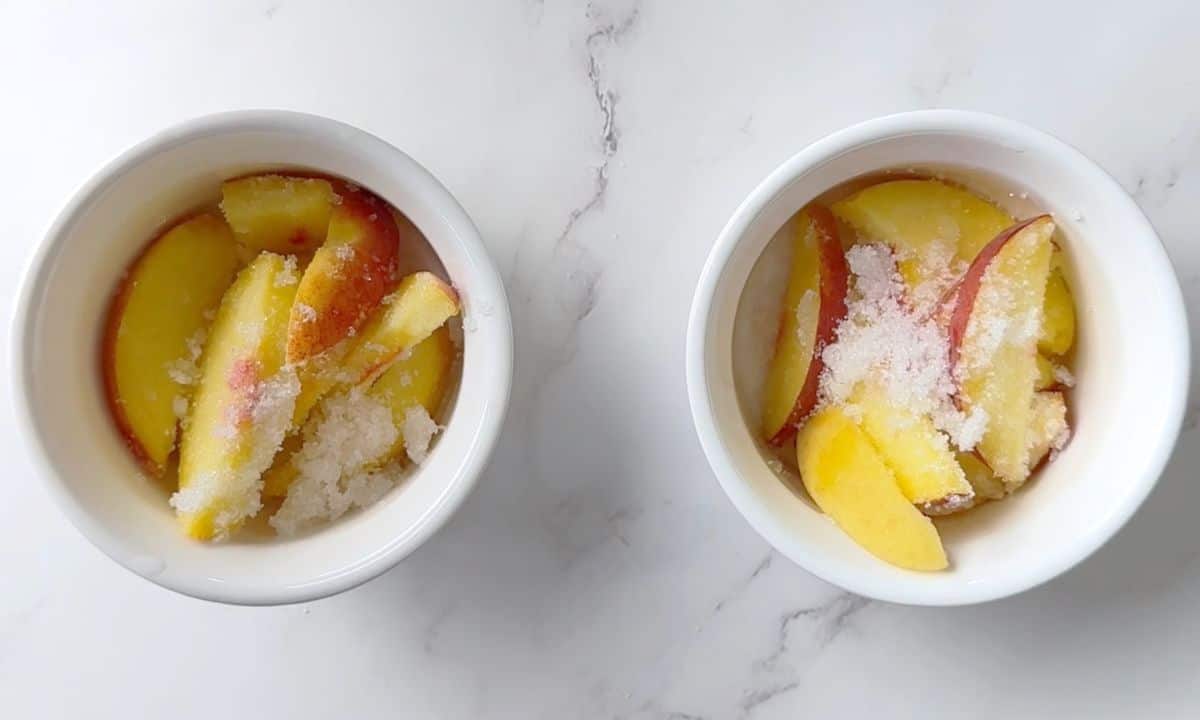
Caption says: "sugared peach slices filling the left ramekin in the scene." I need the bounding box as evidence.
[101,174,461,540]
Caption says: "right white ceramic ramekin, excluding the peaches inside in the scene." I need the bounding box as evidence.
[686,110,1189,605]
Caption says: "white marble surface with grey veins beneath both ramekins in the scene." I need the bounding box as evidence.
[0,0,1200,720]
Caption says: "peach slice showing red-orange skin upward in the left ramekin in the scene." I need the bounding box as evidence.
[287,188,400,364]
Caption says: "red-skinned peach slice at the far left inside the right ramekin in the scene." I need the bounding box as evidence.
[762,205,850,445]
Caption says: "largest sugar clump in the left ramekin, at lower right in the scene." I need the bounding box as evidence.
[270,389,400,535]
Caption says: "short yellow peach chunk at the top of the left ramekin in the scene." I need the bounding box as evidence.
[221,174,338,254]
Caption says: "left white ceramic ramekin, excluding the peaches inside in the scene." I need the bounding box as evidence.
[12,110,512,605]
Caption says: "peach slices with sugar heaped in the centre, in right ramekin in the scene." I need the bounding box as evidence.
[762,176,1075,570]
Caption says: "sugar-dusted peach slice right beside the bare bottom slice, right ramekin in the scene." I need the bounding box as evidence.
[852,385,973,505]
